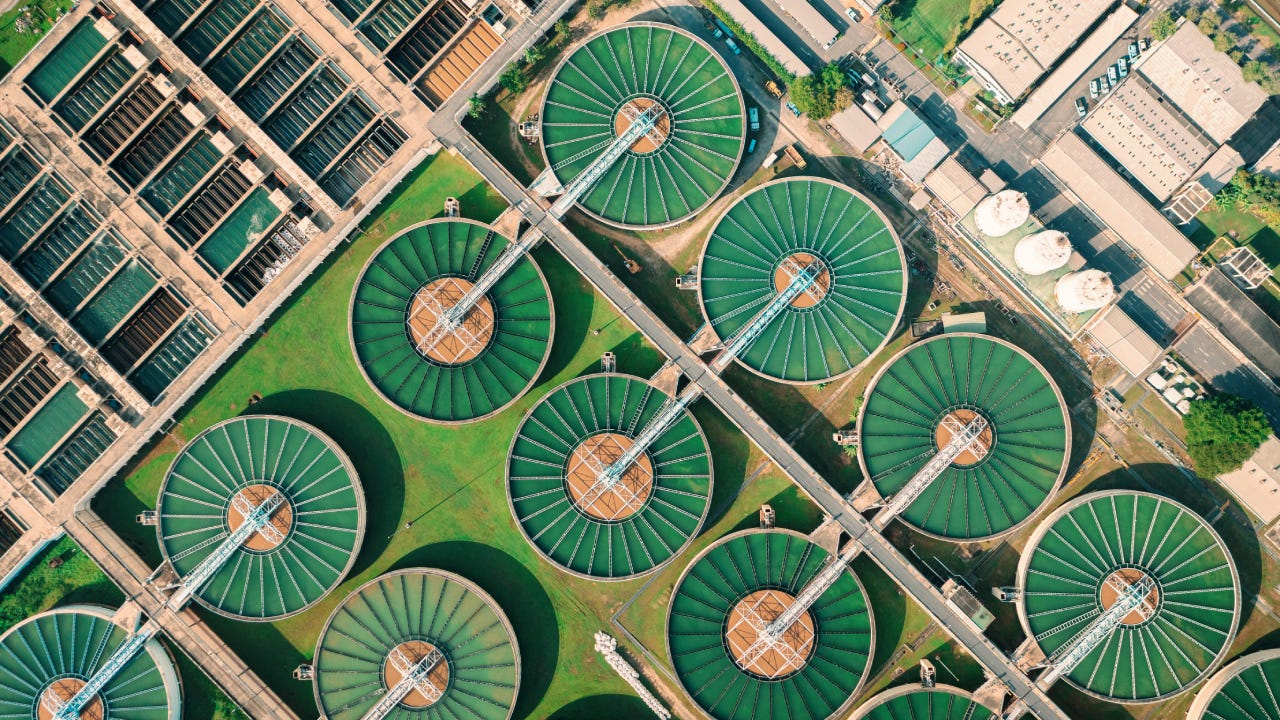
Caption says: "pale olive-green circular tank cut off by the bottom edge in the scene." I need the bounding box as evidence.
[315,568,520,720]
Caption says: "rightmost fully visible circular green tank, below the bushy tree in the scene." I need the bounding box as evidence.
[1018,491,1240,703]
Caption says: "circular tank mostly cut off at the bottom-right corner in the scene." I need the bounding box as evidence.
[1187,650,1280,720]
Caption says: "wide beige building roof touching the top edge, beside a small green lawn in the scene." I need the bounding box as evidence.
[955,0,1115,105]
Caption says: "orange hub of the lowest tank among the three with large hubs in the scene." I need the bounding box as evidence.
[724,591,815,679]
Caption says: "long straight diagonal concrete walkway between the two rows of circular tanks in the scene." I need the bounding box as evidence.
[433,115,1068,720]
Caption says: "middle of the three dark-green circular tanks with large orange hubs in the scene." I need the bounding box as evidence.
[507,373,712,580]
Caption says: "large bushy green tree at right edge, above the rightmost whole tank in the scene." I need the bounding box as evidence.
[1183,393,1271,478]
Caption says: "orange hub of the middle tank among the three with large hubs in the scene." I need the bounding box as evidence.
[564,433,653,521]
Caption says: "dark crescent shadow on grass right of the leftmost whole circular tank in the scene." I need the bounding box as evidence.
[246,389,404,575]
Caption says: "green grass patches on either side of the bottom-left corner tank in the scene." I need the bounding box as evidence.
[0,536,247,720]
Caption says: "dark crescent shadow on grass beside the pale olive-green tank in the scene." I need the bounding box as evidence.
[389,541,559,717]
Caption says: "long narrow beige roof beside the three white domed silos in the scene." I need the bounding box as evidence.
[1041,132,1197,279]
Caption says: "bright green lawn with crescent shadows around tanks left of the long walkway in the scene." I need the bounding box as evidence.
[95,148,788,717]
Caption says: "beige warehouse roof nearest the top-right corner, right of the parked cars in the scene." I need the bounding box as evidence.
[1137,22,1267,143]
